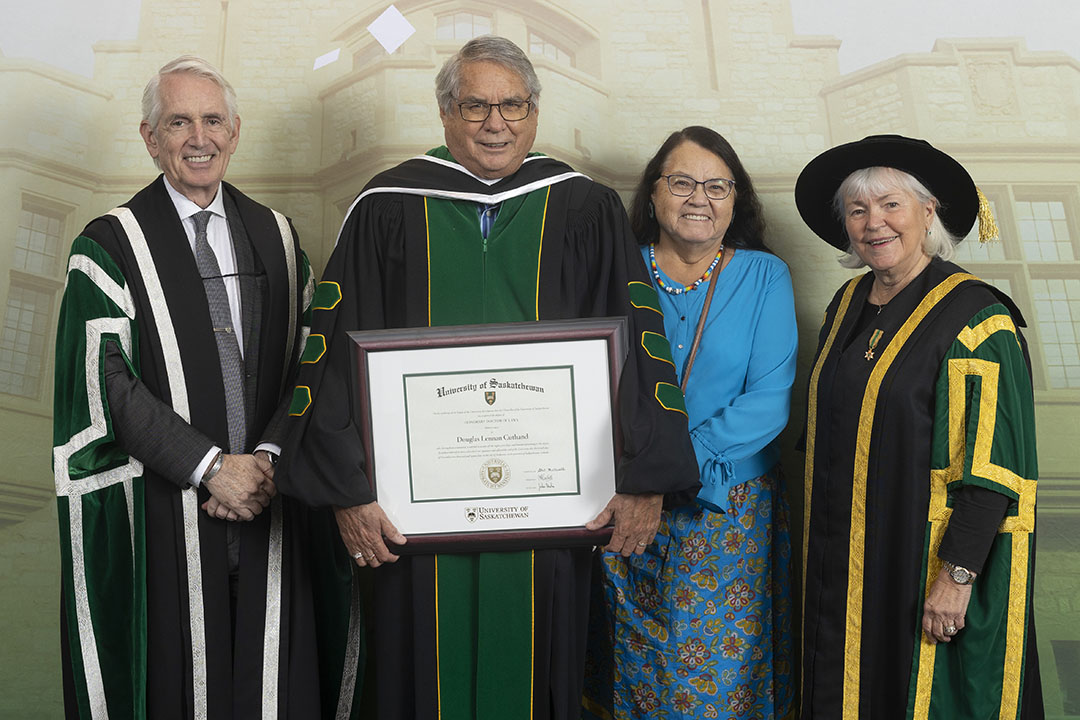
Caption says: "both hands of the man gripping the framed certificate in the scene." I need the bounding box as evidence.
[334,493,664,568]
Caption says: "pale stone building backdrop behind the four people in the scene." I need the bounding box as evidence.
[0,0,1080,718]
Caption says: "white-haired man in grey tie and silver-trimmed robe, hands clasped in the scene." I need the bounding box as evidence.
[54,56,356,719]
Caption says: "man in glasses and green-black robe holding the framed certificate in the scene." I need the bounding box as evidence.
[276,36,699,720]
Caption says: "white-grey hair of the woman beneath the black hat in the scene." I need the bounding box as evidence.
[833,165,961,270]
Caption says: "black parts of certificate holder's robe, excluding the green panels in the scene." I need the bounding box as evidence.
[281,158,700,720]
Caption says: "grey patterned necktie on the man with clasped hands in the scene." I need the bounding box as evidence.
[192,210,246,453]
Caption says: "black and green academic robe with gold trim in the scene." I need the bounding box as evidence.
[801,260,1042,720]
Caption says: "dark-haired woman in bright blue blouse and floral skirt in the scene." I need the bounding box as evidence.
[604,126,797,718]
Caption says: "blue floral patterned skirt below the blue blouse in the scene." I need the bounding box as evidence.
[585,471,794,720]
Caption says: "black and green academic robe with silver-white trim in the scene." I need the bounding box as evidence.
[53,177,359,720]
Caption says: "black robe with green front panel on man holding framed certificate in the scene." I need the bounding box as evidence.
[281,148,699,720]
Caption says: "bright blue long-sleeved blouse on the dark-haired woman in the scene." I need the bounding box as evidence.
[642,246,798,512]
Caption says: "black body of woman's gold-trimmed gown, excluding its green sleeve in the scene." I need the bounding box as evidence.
[800,260,1042,720]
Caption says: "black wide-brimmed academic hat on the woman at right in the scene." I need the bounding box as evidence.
[795,135,978,250]
